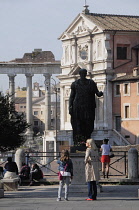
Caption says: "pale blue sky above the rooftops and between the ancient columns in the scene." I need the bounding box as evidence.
[0,0,139,92]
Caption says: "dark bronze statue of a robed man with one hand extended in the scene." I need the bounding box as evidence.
[69,69,103,145]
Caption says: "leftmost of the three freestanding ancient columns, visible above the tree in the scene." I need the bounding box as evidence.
[8,74,16,101]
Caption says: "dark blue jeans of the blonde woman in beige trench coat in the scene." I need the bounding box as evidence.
[88,181,97,200]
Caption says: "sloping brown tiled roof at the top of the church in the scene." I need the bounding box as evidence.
[85,13,139,31]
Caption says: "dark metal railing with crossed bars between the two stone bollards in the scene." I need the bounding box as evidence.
[26,151,128,177]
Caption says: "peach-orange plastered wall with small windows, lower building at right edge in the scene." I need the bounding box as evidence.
[113,80,139,144]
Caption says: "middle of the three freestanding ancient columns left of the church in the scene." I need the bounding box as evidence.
[25,73,34,140]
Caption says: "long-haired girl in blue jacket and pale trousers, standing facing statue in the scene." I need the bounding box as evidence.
[57,150,73,201]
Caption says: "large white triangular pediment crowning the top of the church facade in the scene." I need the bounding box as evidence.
[59,14,102,40]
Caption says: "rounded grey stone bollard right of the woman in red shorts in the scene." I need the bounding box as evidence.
[128,148,138,179]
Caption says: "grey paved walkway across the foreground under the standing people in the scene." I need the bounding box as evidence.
[0,185,139,210]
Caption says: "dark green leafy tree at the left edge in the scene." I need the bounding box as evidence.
[0,95,29,152]
